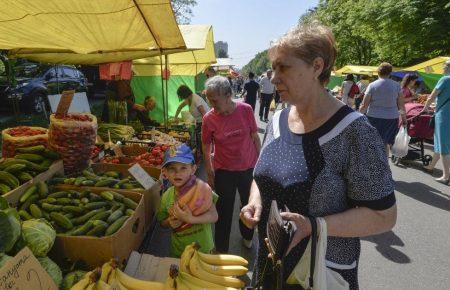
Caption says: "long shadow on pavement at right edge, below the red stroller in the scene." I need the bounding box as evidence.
[395,181,450,211]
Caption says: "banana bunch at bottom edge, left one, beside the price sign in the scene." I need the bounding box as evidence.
[71,260,169,290]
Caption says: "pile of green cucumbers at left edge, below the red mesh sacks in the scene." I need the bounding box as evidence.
[0,145,59,194]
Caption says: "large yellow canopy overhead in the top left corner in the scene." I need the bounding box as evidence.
[0,0,186,64]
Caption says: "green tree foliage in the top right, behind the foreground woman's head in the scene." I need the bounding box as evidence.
[299,0,450,67]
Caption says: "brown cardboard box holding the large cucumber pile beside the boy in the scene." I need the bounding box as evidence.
[49,186,145,268]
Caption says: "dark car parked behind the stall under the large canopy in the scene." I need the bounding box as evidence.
[0,65,87,113]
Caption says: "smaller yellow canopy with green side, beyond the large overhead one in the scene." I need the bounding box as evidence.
[133,25,216,76]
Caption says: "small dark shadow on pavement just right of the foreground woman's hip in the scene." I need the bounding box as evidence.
[361,231,411,264]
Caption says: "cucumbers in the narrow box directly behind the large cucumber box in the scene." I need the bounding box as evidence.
[50,168,142,189]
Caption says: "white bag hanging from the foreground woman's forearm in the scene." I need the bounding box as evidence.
[287,217,349,290]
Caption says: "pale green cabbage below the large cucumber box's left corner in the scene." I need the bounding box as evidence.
[22,219,56,257]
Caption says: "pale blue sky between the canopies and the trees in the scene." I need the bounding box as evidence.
[191,0,318,68]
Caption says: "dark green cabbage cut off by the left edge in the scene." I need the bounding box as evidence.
[0,210,20,253]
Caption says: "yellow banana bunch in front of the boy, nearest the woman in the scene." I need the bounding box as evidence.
[177,243,248,289]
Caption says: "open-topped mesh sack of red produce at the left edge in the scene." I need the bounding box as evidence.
[2,126,48,157]
